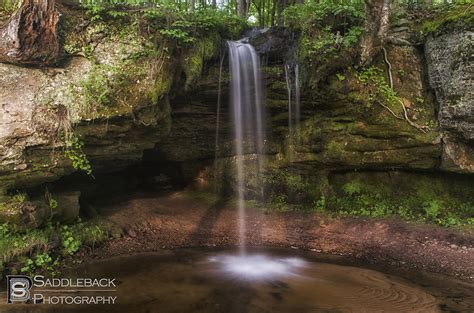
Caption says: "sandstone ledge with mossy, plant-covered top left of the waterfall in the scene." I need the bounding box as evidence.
[0,6,235,224]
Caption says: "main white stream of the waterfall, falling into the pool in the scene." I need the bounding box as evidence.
[227,41,265,255]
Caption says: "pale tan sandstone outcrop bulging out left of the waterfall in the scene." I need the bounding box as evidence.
[0,15,174,194]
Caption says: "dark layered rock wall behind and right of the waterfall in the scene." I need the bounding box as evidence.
[145,26,474,202]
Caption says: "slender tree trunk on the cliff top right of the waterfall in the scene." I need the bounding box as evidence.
[360,0,390,65]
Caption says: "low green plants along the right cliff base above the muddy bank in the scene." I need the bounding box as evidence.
[264,169,474,227]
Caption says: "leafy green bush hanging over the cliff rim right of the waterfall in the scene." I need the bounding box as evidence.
[284,1,364,88]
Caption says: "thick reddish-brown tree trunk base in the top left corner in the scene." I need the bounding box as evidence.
[0,0,60,65]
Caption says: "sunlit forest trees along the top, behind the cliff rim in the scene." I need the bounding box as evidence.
[0,0,471,27]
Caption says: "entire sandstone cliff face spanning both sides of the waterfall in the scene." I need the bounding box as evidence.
[0,14,474,221]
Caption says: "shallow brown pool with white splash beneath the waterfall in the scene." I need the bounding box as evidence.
[0,250,468,313]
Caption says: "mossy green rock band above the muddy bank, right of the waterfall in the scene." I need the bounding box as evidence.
[264,168,474,228]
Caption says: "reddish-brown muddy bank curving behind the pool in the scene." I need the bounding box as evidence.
[78,192,474,282]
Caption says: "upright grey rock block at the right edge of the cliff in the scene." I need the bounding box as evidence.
[425,30,474,173]
